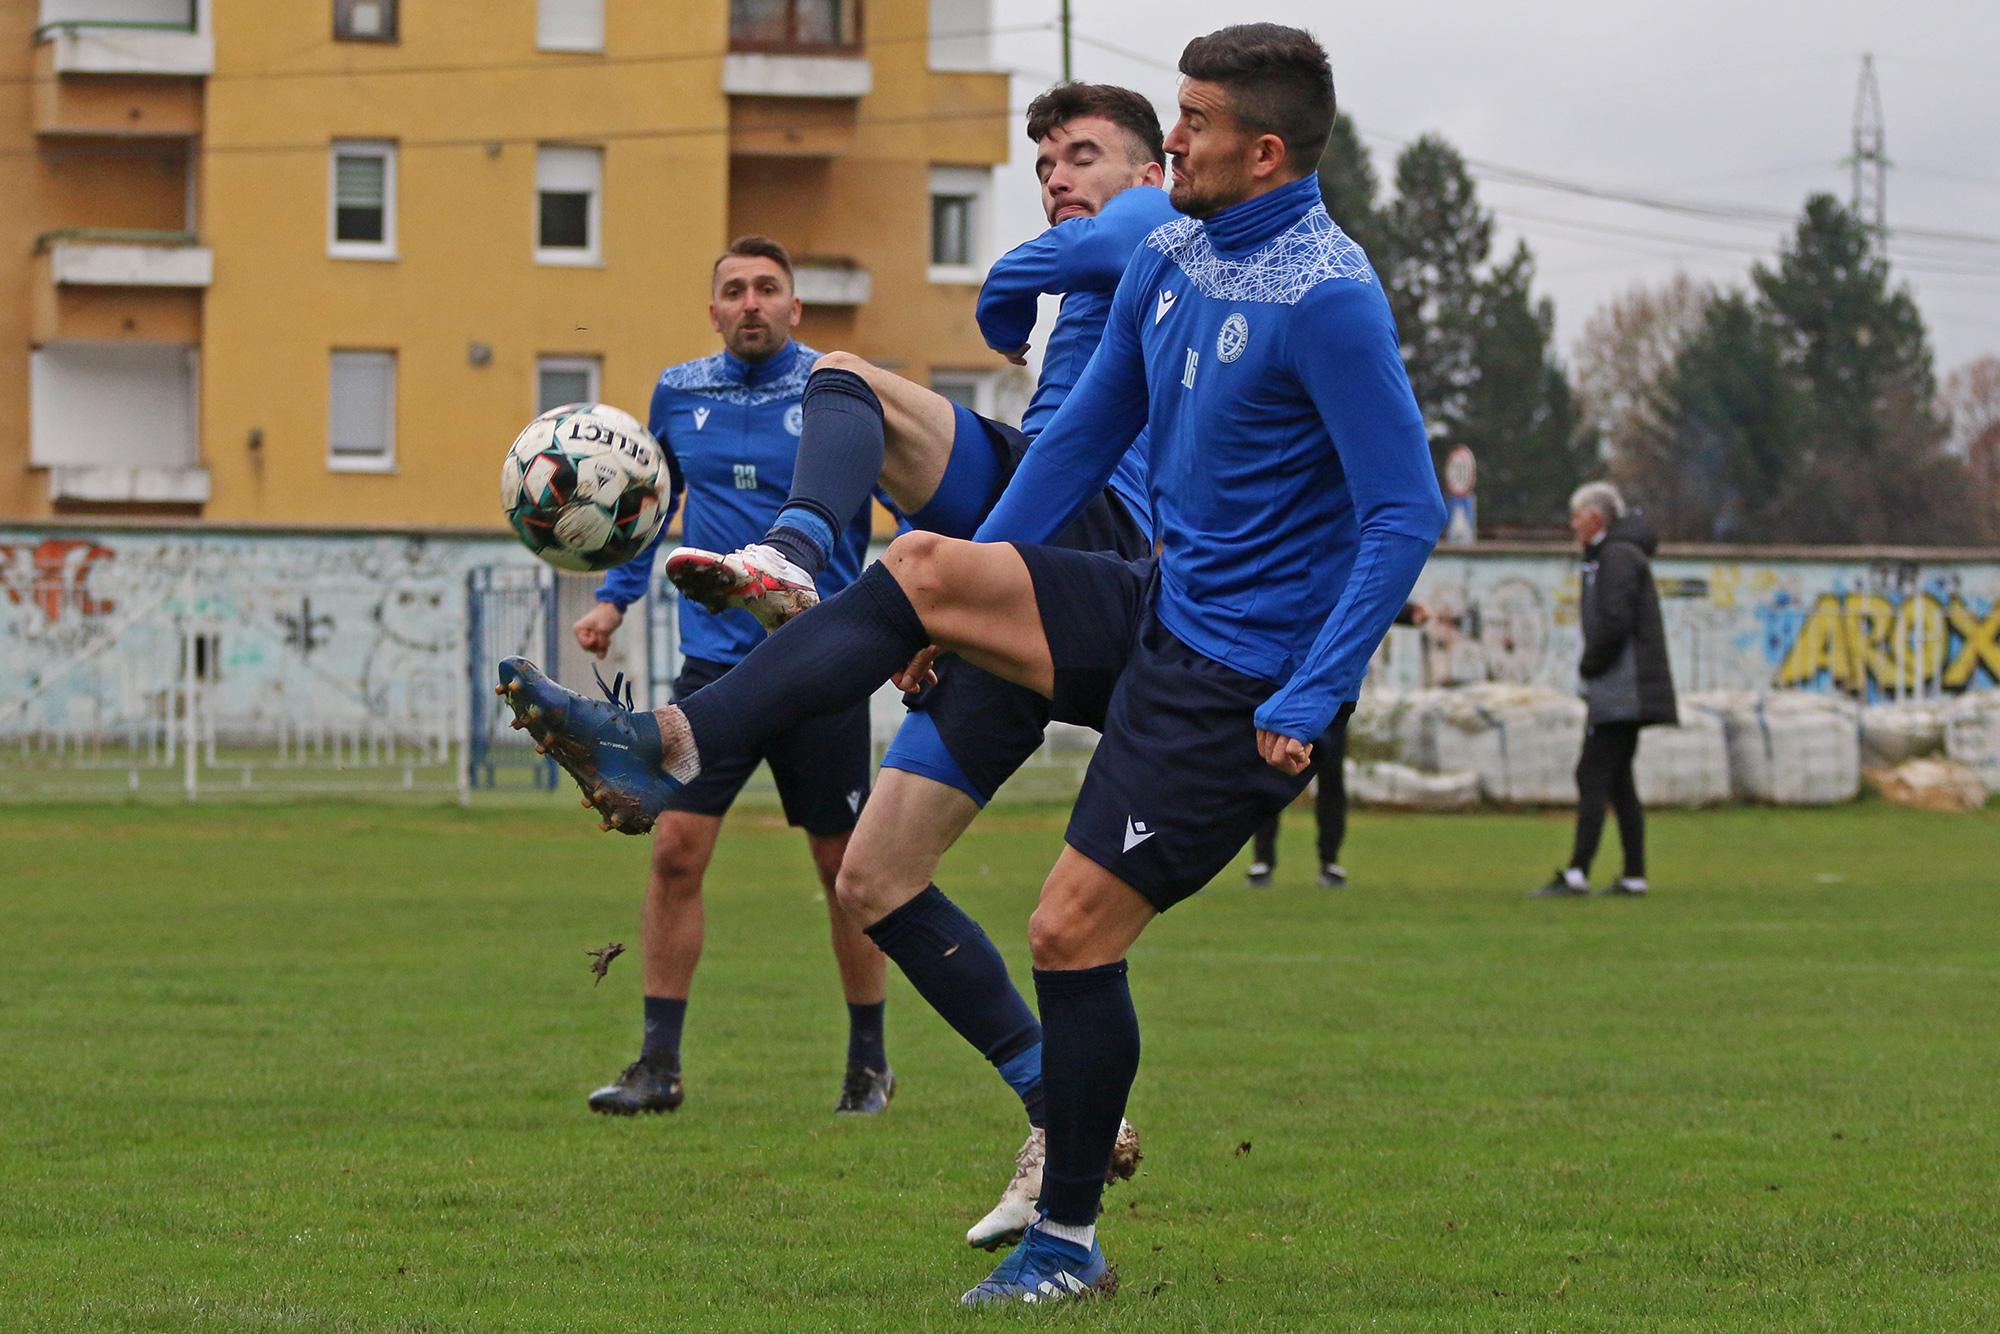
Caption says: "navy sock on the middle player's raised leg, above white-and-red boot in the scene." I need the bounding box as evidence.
[764,368,886,574]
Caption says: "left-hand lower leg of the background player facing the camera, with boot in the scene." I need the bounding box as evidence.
[590,810,722,1116]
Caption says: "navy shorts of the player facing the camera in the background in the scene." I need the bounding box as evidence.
[666,658,870,836]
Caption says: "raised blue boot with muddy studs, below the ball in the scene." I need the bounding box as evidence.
[494,658,680,834]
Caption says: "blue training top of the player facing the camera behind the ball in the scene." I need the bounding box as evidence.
[598,342,872,664]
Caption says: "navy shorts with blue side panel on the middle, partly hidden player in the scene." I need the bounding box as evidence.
[882,408,1152,806]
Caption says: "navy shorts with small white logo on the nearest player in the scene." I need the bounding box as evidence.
[1016,544,1344,912]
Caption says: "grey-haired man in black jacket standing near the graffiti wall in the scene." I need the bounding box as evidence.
[1536,482,1678,898]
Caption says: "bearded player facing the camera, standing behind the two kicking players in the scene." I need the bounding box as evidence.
[574,236,896,1116]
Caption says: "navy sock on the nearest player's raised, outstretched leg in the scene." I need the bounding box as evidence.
[680,562,930,756]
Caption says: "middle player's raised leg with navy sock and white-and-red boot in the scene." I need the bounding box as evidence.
[666,352,958,630]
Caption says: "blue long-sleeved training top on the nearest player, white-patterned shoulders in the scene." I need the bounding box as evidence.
[978,176,1444,742]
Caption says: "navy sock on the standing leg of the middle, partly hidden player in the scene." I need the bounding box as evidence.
[868,884,1042,1126]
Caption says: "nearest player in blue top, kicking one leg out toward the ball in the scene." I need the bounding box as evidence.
[500,24,1444,1304]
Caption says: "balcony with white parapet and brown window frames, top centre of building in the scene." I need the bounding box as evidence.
[722,0,874,100]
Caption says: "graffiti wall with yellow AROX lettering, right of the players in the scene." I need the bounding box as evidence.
[1408,550,2000,700]
